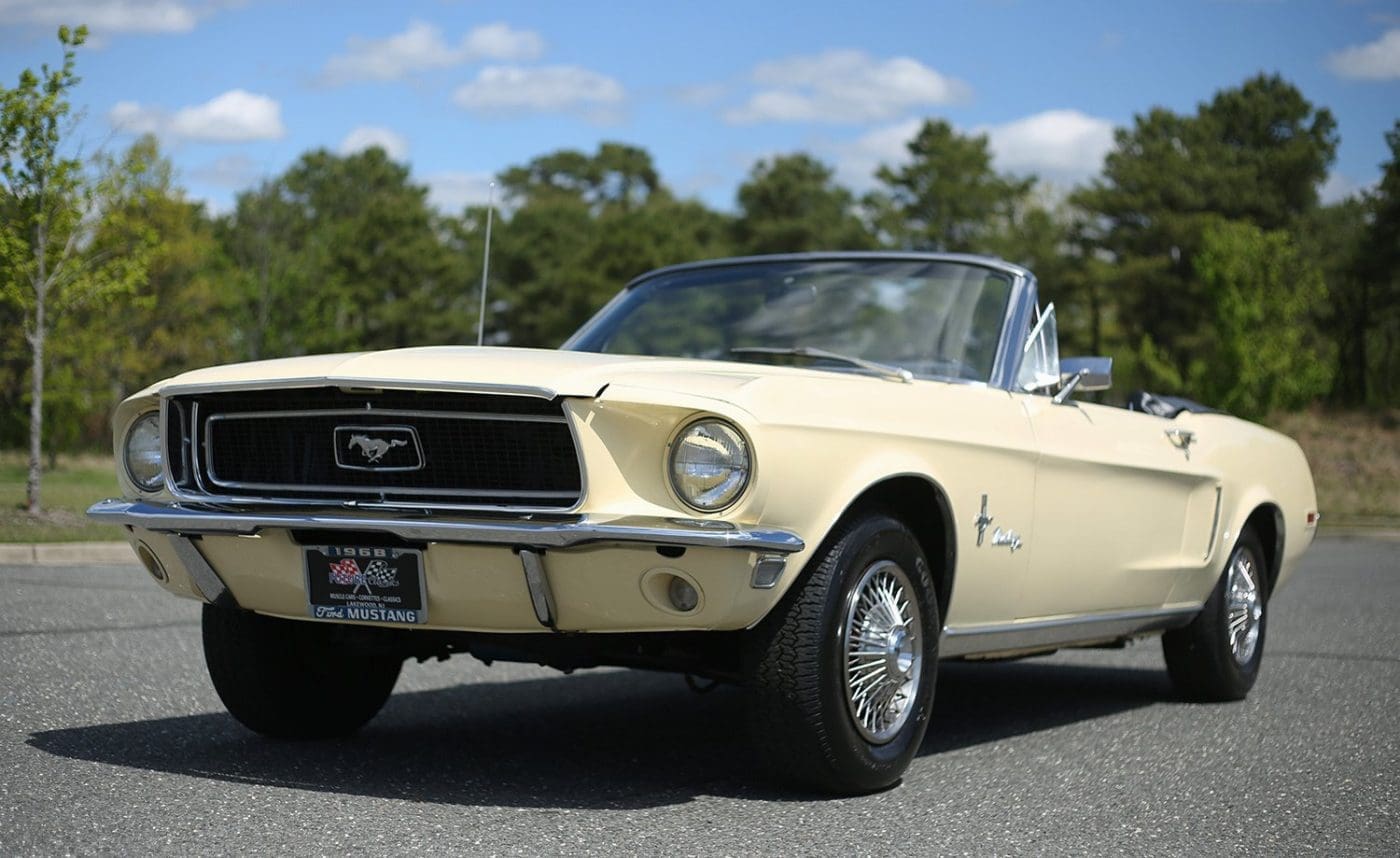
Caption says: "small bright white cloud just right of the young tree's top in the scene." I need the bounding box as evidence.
[106,90,287,143]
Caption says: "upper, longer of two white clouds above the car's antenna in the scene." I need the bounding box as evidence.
[321,21,545,84]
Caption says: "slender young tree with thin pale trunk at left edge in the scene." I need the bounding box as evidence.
[0,27,150,512]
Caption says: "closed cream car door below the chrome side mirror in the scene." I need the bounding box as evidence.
[1019,395,1219,619]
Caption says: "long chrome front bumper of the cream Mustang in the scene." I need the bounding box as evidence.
[88,500,805,554]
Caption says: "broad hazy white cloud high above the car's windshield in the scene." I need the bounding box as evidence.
[725,50,970,123]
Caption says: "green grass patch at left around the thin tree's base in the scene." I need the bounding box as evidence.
[0,451,125,543]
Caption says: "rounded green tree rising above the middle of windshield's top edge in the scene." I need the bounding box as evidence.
[734,153,875,253]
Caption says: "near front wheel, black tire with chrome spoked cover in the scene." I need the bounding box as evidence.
[746,515,942,794]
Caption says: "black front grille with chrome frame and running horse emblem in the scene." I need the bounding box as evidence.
[165,388,582,509]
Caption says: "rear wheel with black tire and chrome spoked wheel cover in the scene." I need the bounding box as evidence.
[1162,530,1268,701]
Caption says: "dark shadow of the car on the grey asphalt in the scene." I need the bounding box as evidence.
[28,662,1172,809]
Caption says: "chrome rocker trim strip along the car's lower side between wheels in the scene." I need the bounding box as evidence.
[938,605,1201,658]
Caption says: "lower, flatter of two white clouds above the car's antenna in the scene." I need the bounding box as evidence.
[452,66,626,122]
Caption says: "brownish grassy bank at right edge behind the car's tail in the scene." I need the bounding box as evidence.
[1270,410,1400,528]
